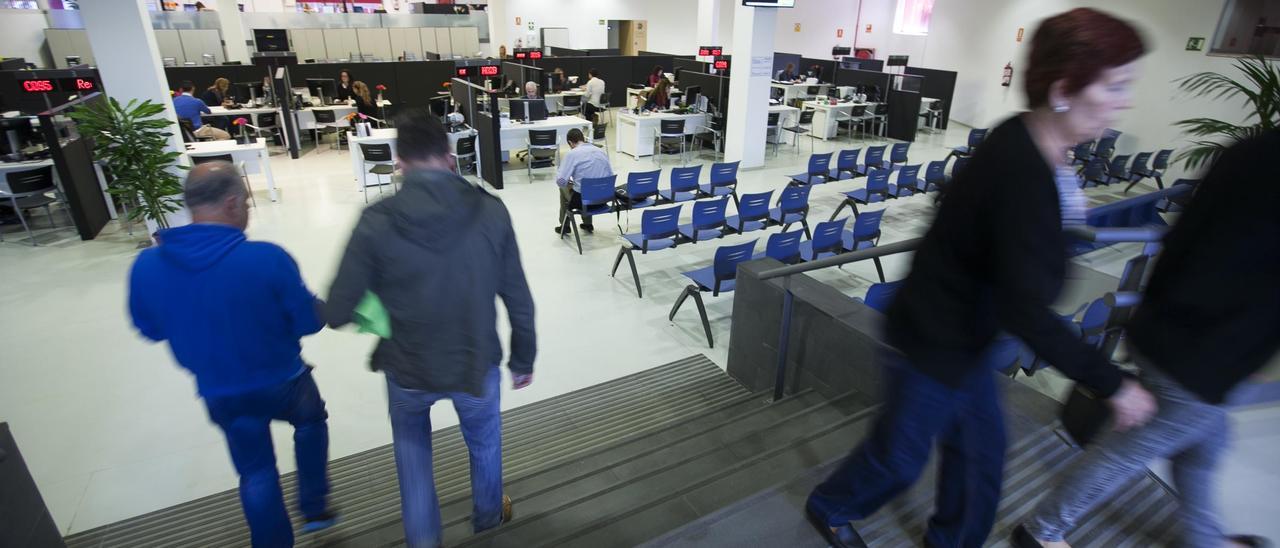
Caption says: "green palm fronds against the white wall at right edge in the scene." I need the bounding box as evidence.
[1174,56,1280,169]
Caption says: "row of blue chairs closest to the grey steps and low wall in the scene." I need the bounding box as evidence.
[670,210,884,348]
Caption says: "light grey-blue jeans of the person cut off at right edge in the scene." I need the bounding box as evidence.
[1027,356,1230,547]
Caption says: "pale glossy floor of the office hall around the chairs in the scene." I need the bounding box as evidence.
[0,116,1280,538]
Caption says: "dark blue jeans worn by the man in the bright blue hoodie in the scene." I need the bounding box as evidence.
[205,367,329,547]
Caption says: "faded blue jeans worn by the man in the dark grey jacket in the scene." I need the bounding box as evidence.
[387,366,502,548]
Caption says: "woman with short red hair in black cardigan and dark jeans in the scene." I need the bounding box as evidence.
[805,9,1155,547]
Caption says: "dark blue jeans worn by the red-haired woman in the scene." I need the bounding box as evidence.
[808,355,1005,547]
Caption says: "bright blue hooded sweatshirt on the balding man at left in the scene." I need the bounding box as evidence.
[129,224,324,398]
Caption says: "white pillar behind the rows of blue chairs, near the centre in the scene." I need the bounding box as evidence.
[724,4,777,168]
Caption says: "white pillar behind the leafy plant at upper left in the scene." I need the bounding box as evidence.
[81,0,183,152]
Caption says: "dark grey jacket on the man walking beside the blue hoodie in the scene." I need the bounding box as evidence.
[325,172,536,396]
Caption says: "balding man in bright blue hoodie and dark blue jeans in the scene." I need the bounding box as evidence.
[129,163,335,547]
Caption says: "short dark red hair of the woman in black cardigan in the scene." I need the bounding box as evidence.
[1024,8,1147,109]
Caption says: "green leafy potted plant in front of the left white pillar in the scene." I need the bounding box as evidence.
[70,97,187,228]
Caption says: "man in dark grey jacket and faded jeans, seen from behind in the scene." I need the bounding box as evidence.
[325,109,536,547]
